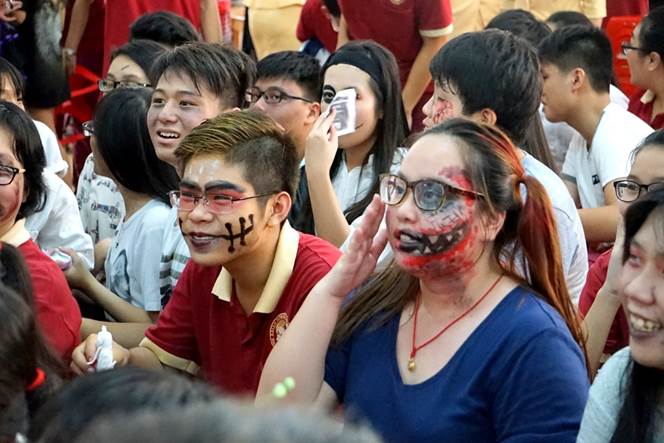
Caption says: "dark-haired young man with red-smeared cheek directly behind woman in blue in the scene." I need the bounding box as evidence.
[423,29,588,303]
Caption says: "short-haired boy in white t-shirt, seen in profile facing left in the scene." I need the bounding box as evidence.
[539,25,653,243]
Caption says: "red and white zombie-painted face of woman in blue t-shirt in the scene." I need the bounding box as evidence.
[387,135,481,278]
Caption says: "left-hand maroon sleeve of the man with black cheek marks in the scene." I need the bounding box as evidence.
[141,265,200,373]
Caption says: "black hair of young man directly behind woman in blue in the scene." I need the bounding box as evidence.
[429,29,542,145]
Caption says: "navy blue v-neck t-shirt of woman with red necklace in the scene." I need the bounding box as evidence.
[325,288,589,443]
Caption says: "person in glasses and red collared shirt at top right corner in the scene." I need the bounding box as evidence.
[622,6,664,129]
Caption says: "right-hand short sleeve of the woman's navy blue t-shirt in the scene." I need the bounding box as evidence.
[491,326,588,443]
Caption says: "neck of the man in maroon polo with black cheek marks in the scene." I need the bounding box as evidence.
[225,226,281,314]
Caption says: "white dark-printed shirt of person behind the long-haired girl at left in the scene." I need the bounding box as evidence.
[76,154,125,244]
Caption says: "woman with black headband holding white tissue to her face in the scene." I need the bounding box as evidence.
[295,41,408,246]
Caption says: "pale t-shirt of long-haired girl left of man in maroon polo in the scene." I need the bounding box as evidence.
[104,200,169,312]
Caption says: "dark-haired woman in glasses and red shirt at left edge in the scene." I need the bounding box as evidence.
[0,101,81,361]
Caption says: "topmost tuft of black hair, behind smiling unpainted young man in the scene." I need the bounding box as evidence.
[129,11,200,47]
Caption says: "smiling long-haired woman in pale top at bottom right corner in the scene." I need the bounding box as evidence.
[577,188,664,443]
